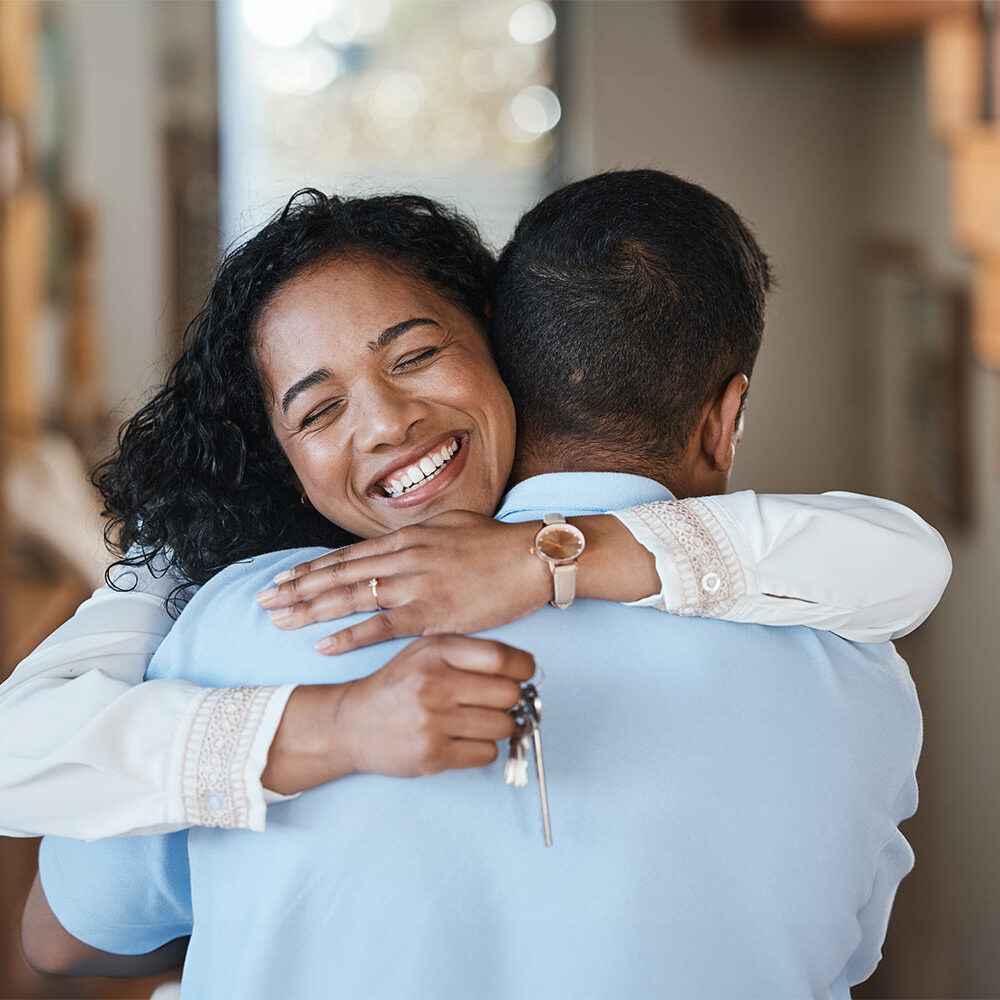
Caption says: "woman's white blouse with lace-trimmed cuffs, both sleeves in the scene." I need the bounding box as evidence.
[0,491,951,840]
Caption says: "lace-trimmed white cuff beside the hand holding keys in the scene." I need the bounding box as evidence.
[181,685,294,830]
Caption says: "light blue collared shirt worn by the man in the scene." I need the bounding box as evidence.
[41,473,921,1000]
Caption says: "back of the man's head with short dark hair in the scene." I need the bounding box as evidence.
[493,170,770,494]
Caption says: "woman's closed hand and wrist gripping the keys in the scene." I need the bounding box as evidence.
[261,635,535,794]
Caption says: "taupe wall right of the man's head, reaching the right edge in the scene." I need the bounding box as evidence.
[563,0,1000,997]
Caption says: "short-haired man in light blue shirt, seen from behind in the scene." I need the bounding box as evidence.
[21,171,920,997]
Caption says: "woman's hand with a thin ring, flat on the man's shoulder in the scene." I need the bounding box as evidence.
[258,511,552,653]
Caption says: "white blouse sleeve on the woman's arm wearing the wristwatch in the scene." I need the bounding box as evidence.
[612,490,951,642]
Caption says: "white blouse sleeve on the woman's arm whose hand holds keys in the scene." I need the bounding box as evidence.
[0,568,293,840]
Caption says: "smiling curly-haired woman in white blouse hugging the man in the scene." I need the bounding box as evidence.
[0,191,948,839]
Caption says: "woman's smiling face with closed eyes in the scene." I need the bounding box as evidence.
[255,258,514,538]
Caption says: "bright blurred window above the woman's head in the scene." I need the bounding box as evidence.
[219,0,561,245]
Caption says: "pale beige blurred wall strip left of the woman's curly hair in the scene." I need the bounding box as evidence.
[49,0,167,414]
